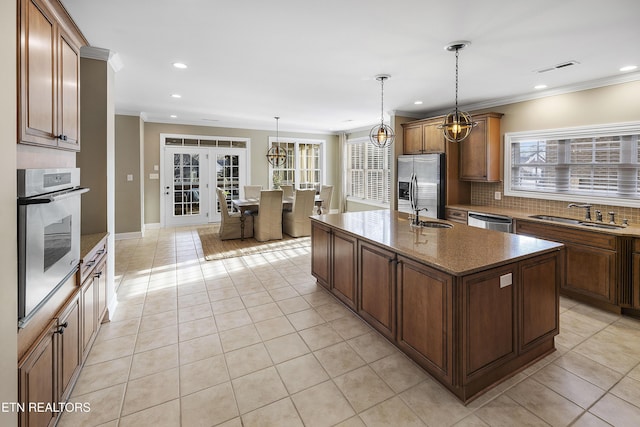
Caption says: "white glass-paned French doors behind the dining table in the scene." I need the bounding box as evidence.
[162,147,249,227]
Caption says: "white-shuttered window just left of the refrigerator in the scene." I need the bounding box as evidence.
[347,138,392,204]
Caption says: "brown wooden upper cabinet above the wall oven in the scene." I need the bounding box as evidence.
[18,0,88,151]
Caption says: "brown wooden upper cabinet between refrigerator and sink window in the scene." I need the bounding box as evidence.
[460,113,502,182]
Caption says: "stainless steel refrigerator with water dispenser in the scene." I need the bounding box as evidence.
[397,154,446,218]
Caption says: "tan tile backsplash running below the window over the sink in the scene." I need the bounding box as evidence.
[471,182,640,225]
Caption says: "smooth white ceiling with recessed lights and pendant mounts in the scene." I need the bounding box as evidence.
[62,0,640,133]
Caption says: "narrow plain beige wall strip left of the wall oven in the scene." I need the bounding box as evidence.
[0,1,18,426]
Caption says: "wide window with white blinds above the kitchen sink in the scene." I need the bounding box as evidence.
[504,123,640,207]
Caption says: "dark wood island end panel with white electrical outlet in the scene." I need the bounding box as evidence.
[462,267,517,383]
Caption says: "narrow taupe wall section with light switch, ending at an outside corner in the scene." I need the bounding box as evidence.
[115,115,142,234]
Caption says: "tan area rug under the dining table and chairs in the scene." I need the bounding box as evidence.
[198,225,311,261]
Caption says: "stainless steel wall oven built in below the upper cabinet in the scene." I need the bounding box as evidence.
[18,168,89,326]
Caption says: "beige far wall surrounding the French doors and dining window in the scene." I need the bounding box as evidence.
[143,123,340,224]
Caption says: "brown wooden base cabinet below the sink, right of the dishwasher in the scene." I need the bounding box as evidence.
[516,220,624,312]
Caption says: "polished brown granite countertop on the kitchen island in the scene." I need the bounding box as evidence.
[311,210,563,276]
